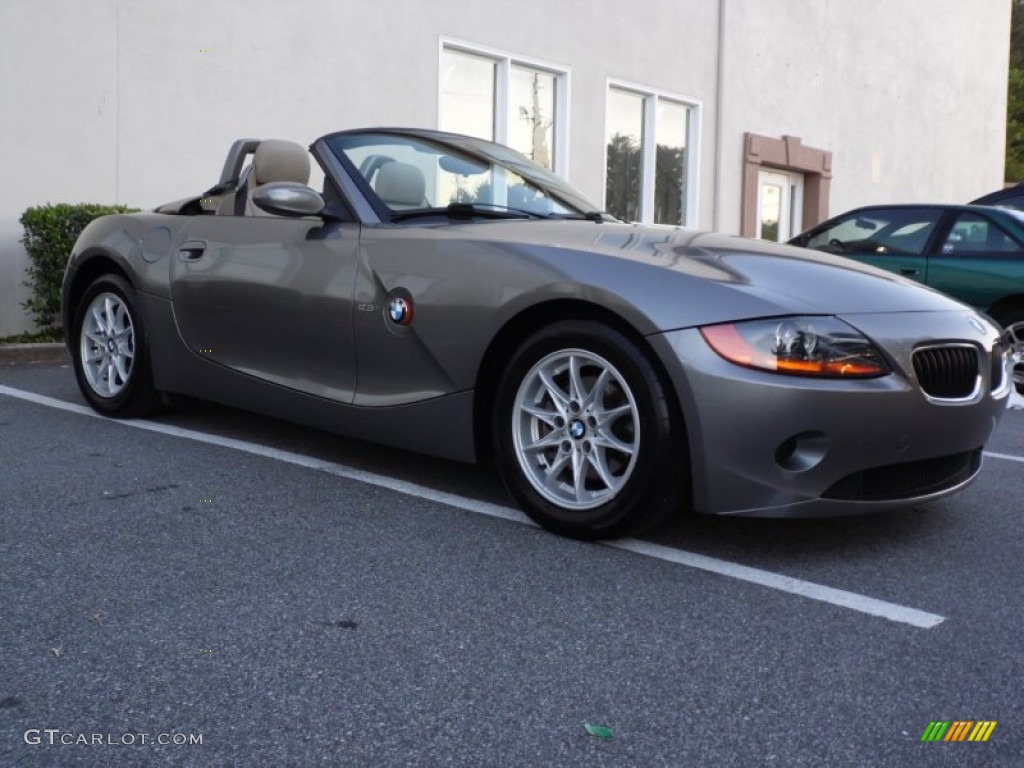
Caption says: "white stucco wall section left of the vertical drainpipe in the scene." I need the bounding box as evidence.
[0,0,717,336]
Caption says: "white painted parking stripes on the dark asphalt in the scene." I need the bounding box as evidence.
[0,384,950,629]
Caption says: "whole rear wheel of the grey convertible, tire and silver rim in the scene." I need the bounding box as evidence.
[72,274,160,418]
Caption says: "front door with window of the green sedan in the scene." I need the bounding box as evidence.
[797,206,942,283]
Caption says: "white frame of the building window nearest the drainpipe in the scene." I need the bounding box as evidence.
[601,78,703,227]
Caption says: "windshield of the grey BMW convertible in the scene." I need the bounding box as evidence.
[327,131,599,219]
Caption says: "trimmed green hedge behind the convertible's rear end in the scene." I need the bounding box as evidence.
[22,203,138,330]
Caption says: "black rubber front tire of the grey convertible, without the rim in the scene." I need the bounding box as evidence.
[494,321,687,539]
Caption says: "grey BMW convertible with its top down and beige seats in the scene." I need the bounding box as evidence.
[63,129,1011,538]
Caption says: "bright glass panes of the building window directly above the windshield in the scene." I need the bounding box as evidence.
[438,42,568,174]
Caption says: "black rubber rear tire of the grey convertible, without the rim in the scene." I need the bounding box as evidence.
[71,274,158,417]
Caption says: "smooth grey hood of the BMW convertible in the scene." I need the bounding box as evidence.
[446,220,968,331]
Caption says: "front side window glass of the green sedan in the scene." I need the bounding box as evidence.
[807,208,939,256]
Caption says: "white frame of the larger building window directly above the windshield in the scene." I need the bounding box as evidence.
[436,37,571,179]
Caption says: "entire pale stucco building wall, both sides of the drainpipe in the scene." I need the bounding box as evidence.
[0,0,1010,336]
